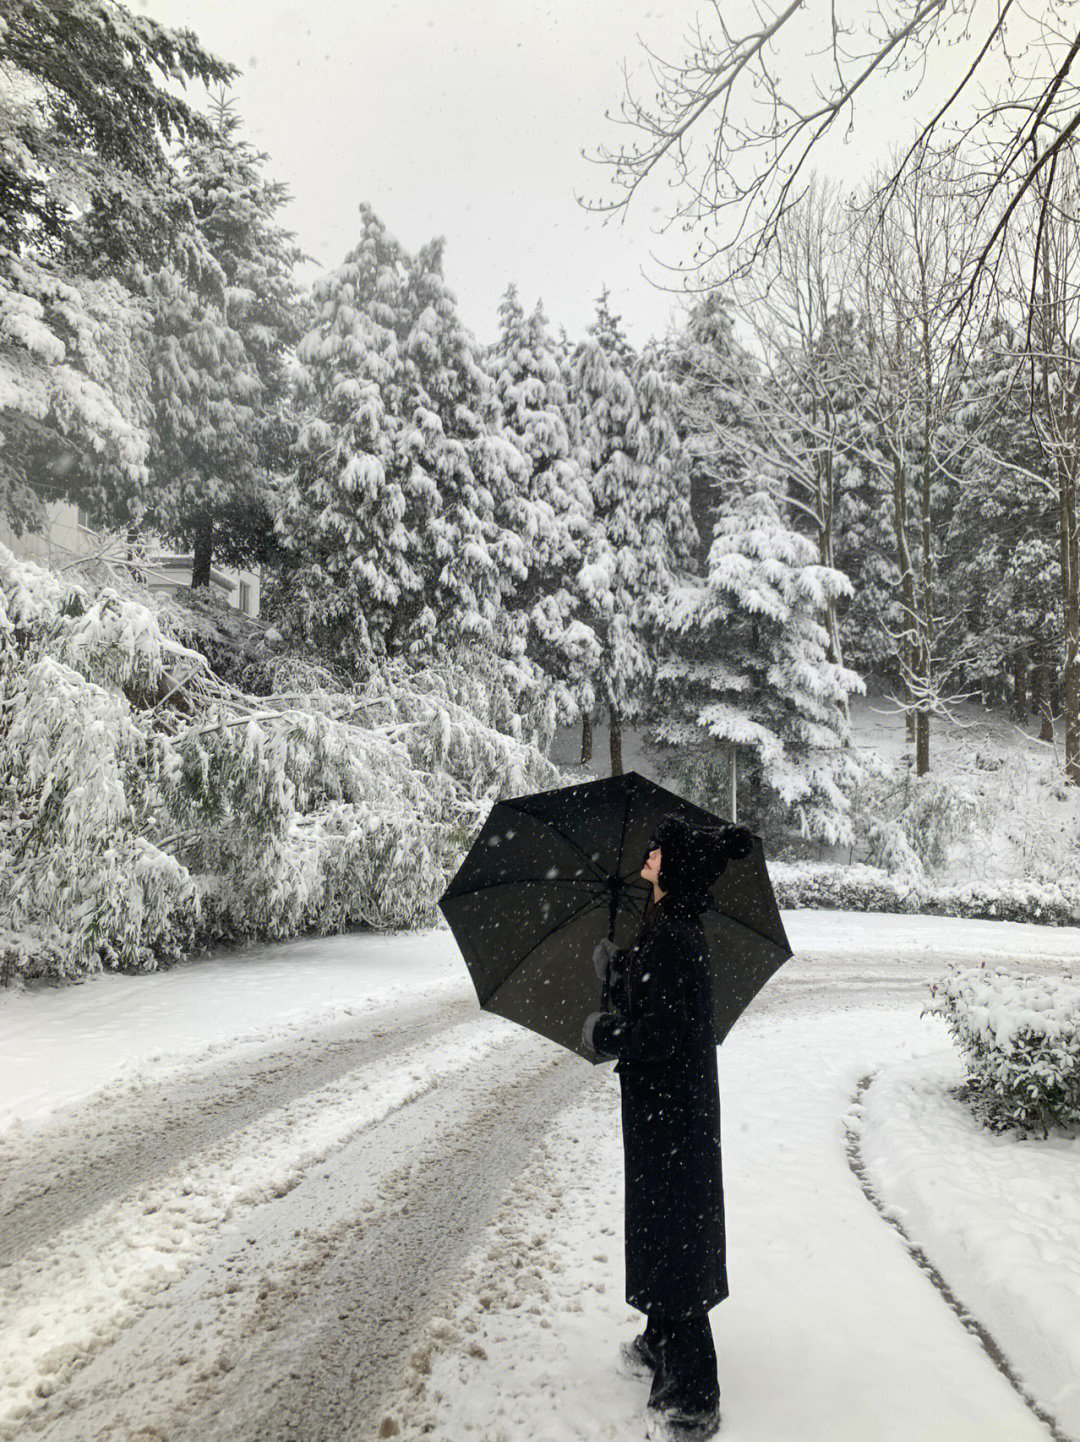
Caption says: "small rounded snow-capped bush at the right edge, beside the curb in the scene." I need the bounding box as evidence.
[927,968,1080,1136]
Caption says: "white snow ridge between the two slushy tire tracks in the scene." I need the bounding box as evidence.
[0,1015,508,1438]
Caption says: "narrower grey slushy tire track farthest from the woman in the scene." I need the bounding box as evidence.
[0,998,477,1269]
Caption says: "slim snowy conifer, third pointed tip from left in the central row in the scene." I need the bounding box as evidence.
[486,284,600,724]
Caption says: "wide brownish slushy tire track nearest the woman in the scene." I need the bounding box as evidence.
[12,1034,585,1442]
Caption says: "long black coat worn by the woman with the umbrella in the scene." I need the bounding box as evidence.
[593,893,728,1318]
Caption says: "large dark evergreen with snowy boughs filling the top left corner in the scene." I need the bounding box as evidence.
[0,0,235,526]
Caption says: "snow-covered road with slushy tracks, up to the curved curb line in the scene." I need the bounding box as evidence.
[0,913,1080,1442]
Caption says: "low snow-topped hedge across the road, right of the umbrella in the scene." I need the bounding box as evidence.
[769,861,1080,926]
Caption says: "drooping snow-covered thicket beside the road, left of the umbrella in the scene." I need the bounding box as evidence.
[0,547,559,979]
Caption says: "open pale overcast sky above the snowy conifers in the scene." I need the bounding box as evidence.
[128,0,1026,345]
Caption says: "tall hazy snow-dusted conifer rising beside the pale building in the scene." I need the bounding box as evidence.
[134,94,301,587]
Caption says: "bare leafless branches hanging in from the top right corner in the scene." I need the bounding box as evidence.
[578,0,1080,301]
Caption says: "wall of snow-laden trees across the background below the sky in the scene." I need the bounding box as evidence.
[0,0,1080,842]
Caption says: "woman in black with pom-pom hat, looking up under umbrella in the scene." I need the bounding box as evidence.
[583,816,750,1439]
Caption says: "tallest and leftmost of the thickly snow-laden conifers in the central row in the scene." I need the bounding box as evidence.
[277,205,415,671]
